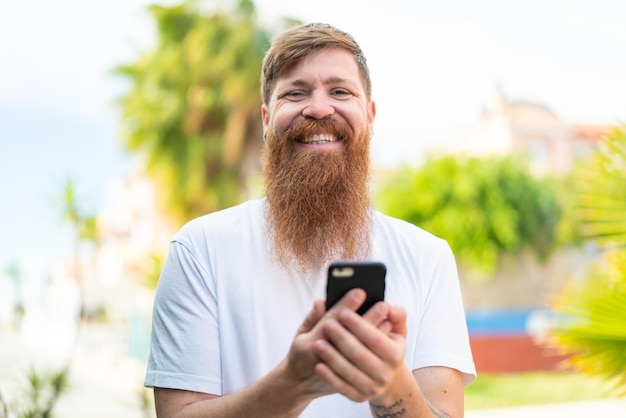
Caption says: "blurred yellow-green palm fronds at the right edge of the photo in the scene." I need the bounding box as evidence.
[554,126,626,395]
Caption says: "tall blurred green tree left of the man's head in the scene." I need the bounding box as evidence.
[117,0,270,222]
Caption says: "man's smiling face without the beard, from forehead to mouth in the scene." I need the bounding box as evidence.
[262,48,376,152]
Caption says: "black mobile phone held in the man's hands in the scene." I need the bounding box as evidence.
[326,261,387,315]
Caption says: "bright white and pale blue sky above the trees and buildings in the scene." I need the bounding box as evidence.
[0,0,626,282]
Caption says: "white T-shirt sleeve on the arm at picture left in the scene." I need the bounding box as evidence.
[144,240,222,395]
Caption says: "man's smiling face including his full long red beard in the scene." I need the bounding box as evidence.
[263,49,375,271]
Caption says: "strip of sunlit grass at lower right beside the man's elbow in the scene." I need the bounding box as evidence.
[465,372,614,410]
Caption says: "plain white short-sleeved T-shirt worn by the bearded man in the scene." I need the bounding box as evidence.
[144,199,476,418]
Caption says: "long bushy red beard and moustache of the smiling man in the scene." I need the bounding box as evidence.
[264,120,370,272]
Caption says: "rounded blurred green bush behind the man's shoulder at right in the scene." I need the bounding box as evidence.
[376,157,562,276]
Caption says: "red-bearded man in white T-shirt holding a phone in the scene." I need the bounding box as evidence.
[145,24,475,418]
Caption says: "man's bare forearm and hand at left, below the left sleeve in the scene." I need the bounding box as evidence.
[155,289,390,418]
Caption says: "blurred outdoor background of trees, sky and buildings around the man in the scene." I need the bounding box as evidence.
[0,0,626,418]
